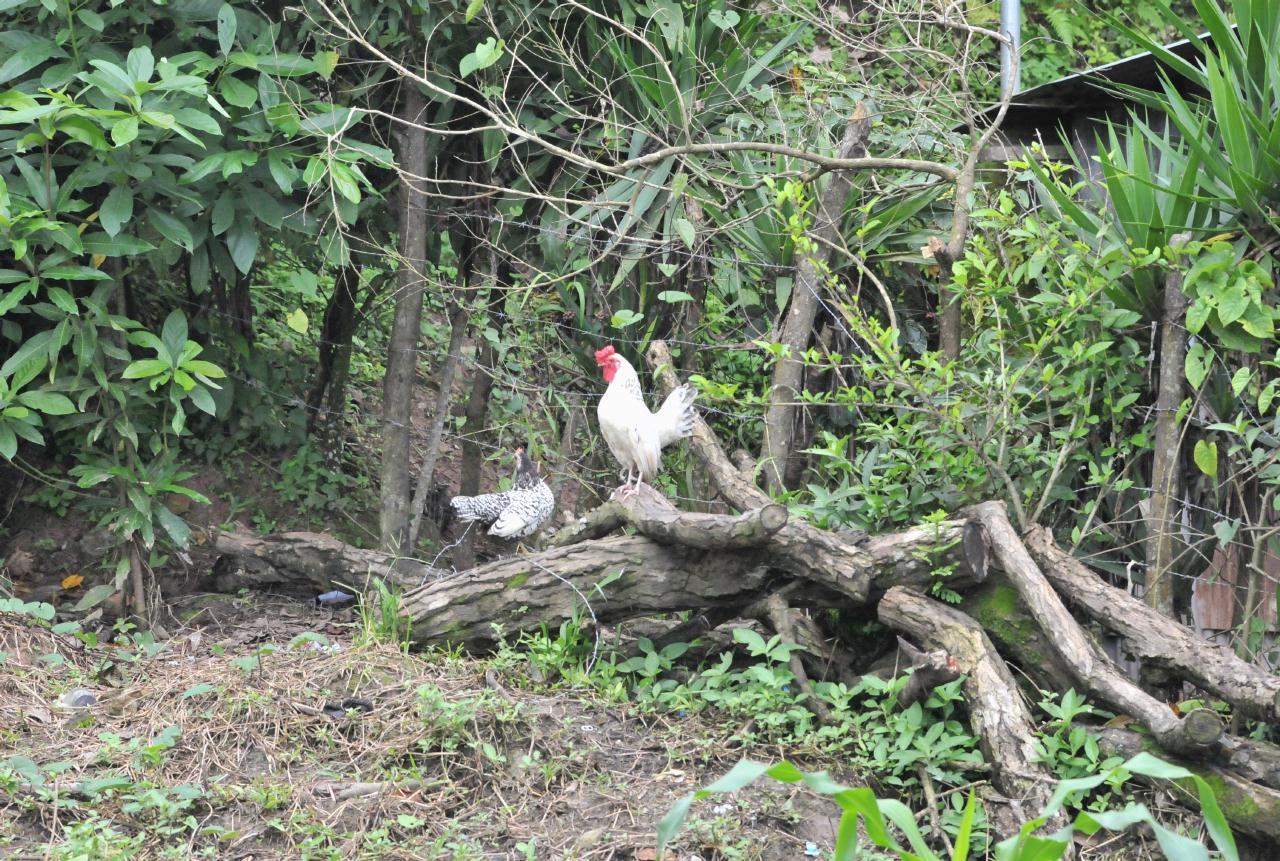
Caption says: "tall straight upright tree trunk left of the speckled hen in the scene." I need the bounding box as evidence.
[379,84,428,553]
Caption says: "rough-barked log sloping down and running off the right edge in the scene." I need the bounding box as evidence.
[1025,526,1280,722]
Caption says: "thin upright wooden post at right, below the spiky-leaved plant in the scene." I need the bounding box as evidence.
[1143,233,1190,618]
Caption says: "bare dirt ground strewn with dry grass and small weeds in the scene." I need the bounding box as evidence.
[0,597,860,861]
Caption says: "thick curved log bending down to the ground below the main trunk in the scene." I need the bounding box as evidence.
[878,587,1066,839]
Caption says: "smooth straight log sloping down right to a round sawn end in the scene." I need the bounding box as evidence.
[972,502,1224,755]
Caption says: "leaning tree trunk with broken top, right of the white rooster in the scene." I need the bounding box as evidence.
[760,104,872,494]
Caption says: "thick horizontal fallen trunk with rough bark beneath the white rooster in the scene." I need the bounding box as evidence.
[402,489,988,647]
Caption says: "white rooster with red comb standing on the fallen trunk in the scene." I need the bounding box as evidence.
[595,345,698,495]
